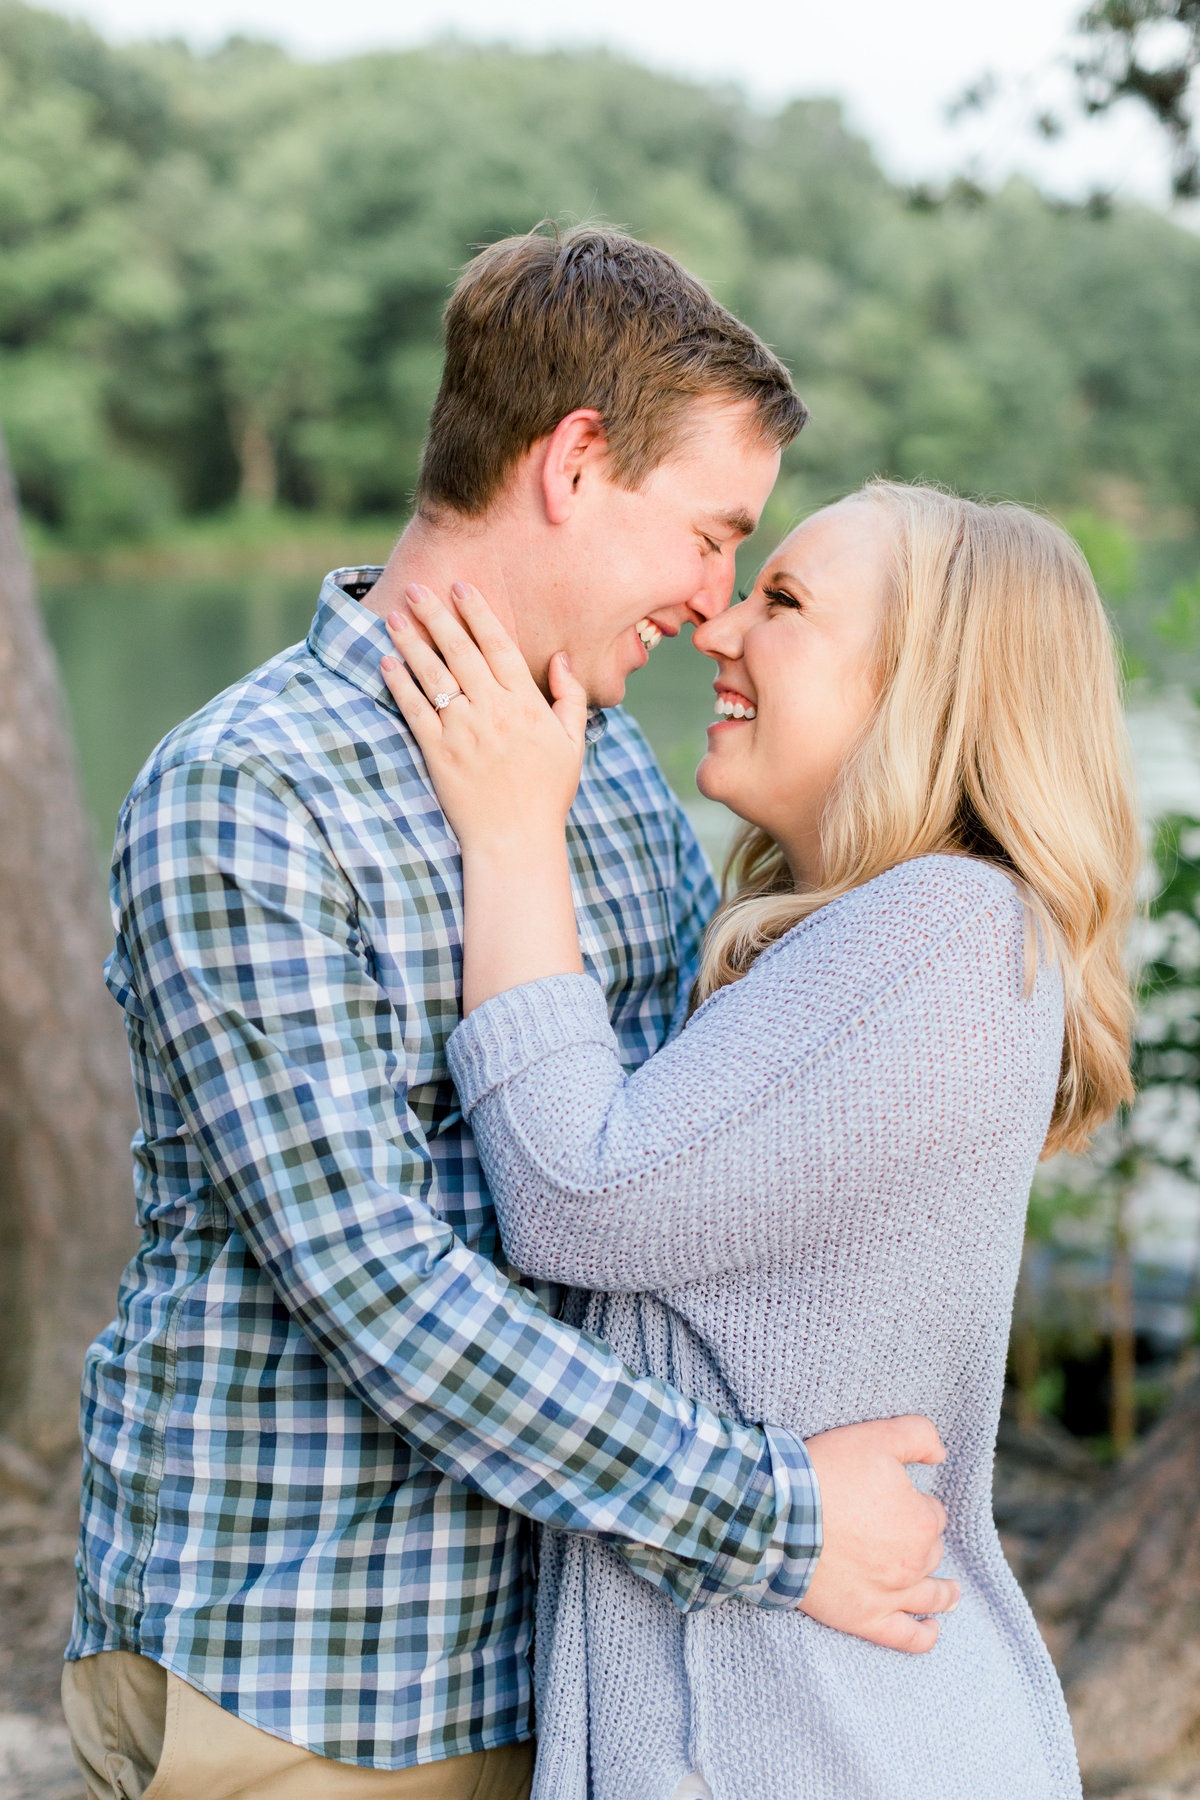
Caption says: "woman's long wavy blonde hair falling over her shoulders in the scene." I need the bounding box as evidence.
[696,481,1141,1156]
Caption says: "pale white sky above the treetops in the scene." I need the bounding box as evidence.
[41,0,1166,202]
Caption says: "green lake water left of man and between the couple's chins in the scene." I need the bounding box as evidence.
[41,571,732,860]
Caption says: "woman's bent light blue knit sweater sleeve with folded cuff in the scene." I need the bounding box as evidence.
[450,857,1043,1292]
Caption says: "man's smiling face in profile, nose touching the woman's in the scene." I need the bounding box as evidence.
[522,400,779,706]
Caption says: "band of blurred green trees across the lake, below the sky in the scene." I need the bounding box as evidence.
[0,0,1200,545]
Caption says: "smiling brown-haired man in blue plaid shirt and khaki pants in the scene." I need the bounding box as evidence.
[65,230,954,1800]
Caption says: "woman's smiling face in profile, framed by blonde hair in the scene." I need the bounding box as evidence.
[693,497,892,886]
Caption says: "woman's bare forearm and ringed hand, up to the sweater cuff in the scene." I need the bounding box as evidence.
[381,581,588,1013]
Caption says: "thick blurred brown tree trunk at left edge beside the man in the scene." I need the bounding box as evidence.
[0,432,133,1461]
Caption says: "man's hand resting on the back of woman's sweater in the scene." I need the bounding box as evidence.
[801,1418,959,1652]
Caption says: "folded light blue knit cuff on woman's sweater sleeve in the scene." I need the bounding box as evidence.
[446,976,617,1116]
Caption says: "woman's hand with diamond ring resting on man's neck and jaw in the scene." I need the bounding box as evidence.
[381,581,587,851]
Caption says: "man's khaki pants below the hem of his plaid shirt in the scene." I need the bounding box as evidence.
[63,1651,534,1800]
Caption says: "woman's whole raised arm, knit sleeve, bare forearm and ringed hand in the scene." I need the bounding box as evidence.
[385,589,1022,1291]
